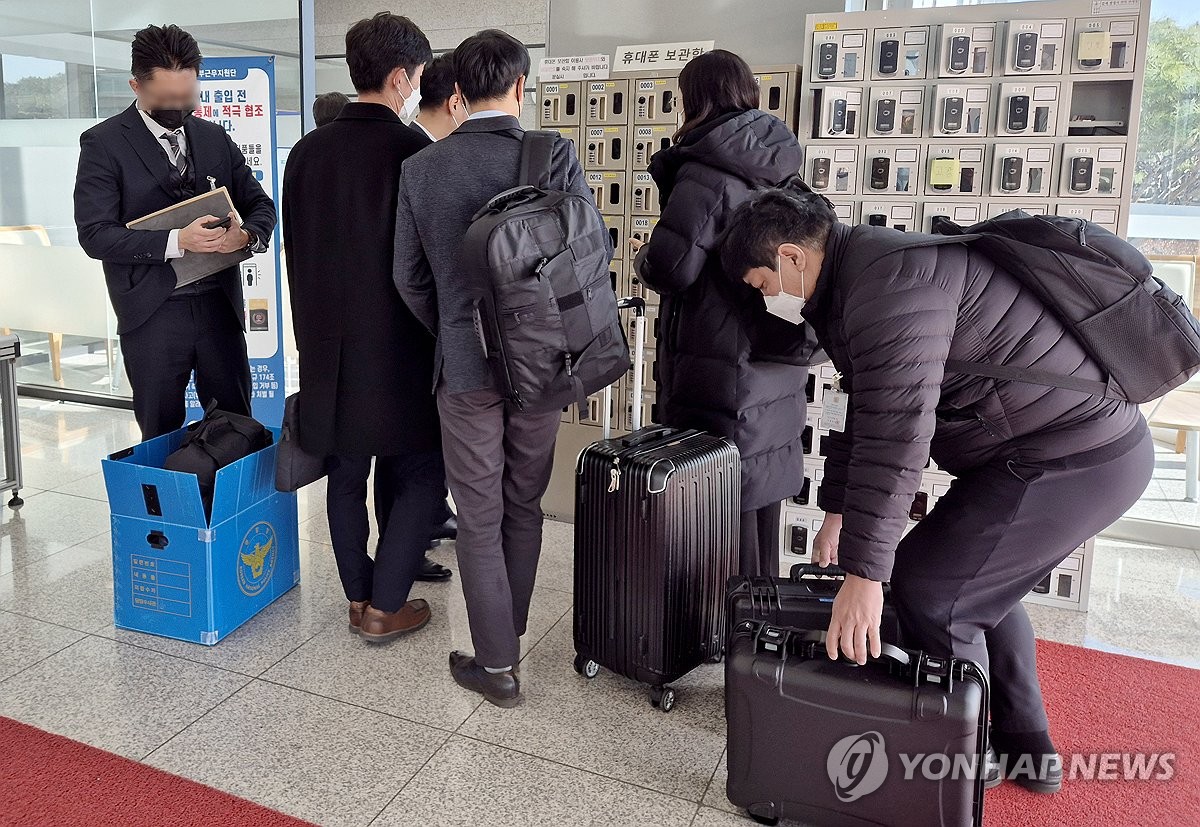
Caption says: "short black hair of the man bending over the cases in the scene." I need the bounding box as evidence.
[721,187,838,282]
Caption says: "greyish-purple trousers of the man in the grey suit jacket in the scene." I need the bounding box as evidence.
[438,390,562,669]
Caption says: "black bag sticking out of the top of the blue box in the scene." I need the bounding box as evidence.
[162,402,275,517]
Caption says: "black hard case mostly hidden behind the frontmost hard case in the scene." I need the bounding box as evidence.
[726,563,902,645]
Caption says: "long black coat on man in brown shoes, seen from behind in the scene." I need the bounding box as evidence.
[282,103,440,456]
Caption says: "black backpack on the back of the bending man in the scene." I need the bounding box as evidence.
[934,210,1200,403]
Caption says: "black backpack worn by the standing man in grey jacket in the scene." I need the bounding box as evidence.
[462,132,630,413]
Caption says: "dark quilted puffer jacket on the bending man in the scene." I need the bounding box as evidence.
[804,223,1144,580]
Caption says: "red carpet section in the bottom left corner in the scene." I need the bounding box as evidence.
[0,718,308,827]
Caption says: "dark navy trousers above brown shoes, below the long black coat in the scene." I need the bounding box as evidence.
[326,451,445,612]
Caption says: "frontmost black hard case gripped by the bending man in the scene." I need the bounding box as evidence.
[725,621,988,827]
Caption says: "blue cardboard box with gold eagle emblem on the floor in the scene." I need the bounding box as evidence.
[103,429,300,646]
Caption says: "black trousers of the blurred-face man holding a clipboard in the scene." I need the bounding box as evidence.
[121,290,251,439]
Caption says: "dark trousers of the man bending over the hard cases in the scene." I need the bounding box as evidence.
[892,431,1154,732]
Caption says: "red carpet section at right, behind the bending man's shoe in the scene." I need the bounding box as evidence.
[984,641,1200,827]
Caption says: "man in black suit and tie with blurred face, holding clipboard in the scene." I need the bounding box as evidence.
[74,25,275,439]
